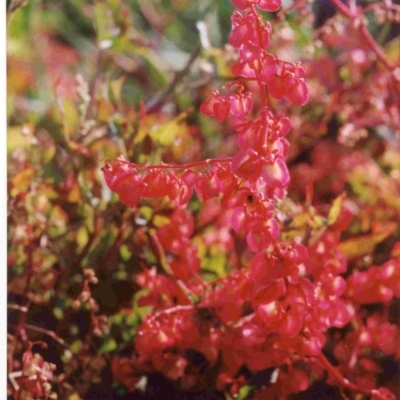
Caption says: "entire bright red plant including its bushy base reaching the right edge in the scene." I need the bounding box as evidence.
[103,0,400,399]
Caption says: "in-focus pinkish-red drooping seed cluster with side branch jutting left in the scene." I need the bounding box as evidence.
[103,0,397,399]
